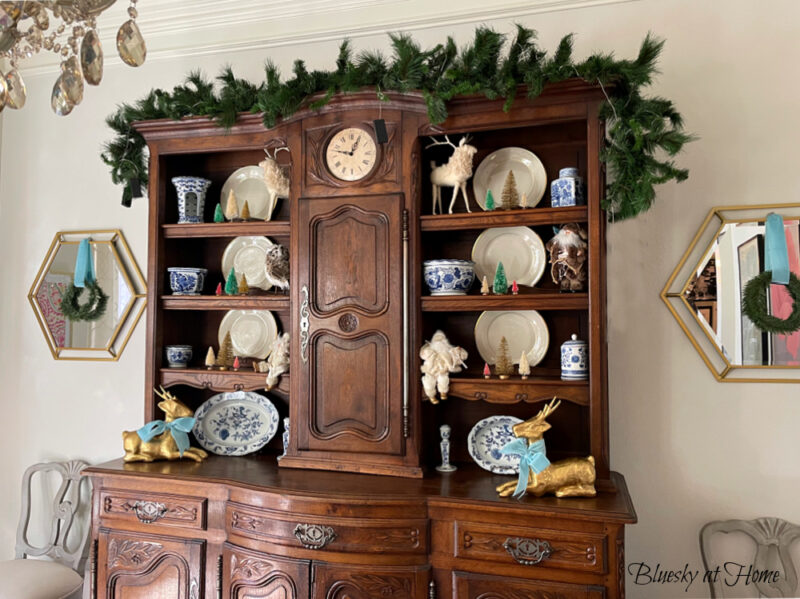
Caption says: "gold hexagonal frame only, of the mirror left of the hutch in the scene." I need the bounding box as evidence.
[28,229,147,362]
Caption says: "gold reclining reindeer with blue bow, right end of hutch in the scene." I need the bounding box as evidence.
[497,398,597,497]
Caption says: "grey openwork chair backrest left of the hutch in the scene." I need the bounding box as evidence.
[15,460,89,571]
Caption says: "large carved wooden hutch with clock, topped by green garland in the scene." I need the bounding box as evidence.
[87,81,636,599]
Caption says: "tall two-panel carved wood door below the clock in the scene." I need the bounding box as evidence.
[292,195,404,461]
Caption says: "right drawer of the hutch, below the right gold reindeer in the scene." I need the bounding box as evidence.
[454,520,606,574]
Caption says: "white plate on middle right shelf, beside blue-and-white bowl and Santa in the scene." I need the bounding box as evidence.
[472,227,547,287]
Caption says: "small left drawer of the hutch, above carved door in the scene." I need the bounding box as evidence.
[100,490,208,530]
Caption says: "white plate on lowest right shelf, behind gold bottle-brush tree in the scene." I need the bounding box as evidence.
[475,310,550,366]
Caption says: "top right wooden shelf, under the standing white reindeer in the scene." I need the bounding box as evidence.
[418,206,589,231]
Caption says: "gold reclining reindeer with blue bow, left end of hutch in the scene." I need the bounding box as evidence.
[122,387,208,462]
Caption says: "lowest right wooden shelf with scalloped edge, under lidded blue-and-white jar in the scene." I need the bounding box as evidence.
[449,376,589,406]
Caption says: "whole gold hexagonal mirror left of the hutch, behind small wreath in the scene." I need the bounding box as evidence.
[28,230,147,361]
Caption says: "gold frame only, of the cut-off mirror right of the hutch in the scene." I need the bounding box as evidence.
[661,203,800,383]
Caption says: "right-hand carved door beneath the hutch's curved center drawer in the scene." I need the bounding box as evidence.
[311,561,430,599]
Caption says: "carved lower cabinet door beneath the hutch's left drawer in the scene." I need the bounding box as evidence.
[97,529,205,599]
